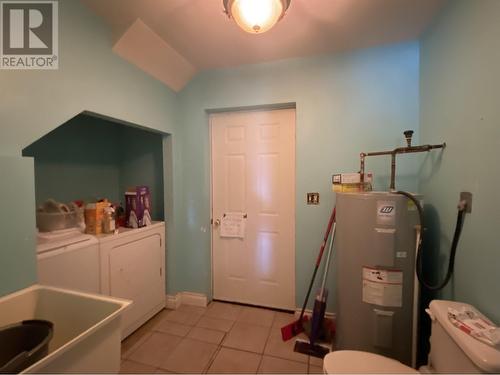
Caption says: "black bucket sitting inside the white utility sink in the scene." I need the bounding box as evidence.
[0,320,54,374]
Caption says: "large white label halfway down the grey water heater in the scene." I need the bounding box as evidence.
[362,267,403,307]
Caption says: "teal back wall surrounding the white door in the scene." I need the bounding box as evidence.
[171,43,419,306]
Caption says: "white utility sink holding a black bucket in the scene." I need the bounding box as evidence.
[0,285,132,373]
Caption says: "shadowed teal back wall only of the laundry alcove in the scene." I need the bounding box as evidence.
[23,115,120,206]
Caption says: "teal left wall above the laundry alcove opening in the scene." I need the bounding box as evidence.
[0,0,178,298]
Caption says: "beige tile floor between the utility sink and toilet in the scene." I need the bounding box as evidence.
[121,302,322,374]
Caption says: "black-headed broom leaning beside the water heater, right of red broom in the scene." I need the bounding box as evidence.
[293,223,337,358]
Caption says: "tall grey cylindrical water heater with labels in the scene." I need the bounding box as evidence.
[335,192,419,366]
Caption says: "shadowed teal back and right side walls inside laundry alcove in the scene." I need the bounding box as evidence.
[23,115,164,220]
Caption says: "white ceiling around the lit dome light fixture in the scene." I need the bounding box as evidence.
[82,0,446,89]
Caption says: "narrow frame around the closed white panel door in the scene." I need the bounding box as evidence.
[205,102,297,312]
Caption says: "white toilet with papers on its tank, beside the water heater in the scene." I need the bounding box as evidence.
[323,300,500,374]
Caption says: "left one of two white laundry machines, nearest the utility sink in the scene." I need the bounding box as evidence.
[36,229,101,293]
